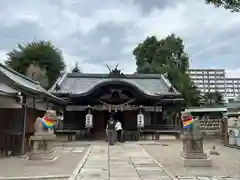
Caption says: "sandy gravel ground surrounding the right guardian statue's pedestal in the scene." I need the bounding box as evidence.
[141,140,240,176]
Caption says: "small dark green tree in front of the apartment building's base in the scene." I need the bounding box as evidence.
[203,91,224,105]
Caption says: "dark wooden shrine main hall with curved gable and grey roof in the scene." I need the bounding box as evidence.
[50,69,182,138]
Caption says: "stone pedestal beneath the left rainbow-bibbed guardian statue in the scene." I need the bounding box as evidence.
[28,133,58,164]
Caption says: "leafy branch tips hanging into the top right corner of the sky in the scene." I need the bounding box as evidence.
[205,0,240,12]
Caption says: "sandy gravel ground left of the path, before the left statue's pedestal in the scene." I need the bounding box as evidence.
[0,145,89,178]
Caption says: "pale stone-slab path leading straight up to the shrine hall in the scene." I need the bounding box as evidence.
[75,143,239,180]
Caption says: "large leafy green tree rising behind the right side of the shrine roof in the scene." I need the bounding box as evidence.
[133,34,200,106]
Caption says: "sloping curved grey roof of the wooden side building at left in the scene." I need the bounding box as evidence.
[0,63,64,102]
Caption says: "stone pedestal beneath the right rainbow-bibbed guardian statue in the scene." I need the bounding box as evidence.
[180,135,212,167]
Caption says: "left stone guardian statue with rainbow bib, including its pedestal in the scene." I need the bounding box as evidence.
[28,110,58,164]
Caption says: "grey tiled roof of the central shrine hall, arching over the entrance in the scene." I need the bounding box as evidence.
[50,73,179,96]
